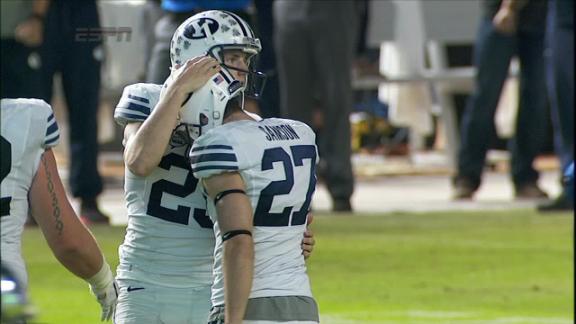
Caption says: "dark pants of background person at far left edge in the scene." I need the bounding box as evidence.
[0,39,42,98]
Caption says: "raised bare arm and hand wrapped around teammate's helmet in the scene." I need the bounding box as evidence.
[124,56,220,176]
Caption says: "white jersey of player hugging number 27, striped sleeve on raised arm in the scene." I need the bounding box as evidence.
[114,83,214,288]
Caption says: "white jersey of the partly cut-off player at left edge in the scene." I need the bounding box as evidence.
[0,99,60,286]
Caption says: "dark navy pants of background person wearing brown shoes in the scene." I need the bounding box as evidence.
[457,18,548,188]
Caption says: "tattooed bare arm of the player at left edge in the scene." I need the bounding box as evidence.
[28,150,105,280]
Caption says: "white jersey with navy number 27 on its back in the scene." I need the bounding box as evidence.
[190,118,318,305]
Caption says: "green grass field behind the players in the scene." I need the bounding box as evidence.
[23,210,574,324]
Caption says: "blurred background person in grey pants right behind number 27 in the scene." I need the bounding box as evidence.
[273,0,358,212]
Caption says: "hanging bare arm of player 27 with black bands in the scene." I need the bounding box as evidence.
[204,172,254,324]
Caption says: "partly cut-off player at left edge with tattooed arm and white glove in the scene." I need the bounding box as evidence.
[0,99,117,320]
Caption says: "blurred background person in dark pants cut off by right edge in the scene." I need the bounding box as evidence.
[538,0,574,212]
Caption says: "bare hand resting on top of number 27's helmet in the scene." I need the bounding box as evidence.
[172,56,220,93]
